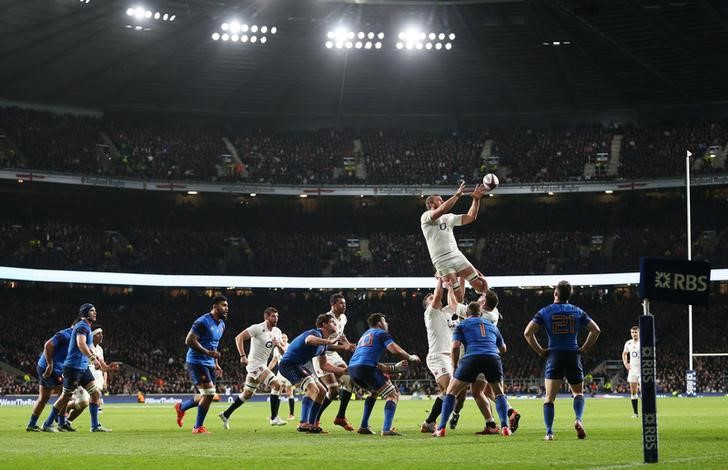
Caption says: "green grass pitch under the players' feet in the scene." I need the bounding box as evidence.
[0,397,728,470]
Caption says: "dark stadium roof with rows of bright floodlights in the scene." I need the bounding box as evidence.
[0,0,728,116]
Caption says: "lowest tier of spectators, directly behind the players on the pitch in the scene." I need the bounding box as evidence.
[0,286,728,394]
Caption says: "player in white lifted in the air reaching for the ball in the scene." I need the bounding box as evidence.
[420,183,488,302]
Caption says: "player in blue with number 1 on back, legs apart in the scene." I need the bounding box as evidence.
[432,302,511,437]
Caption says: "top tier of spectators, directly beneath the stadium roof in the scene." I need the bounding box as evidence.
[0,108,728,185]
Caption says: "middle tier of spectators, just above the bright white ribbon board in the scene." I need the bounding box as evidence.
[0,220,728,277]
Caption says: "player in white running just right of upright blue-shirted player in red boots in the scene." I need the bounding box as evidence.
[218,307,288,429]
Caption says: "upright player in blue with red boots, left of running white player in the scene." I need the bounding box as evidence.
[174,295,229,434]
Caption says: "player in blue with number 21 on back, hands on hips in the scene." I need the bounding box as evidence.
[523,281,601,441]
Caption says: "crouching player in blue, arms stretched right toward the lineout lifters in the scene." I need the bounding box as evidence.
[349,313,420,436]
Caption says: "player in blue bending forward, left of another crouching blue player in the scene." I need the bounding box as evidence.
[278,313,346,434]
